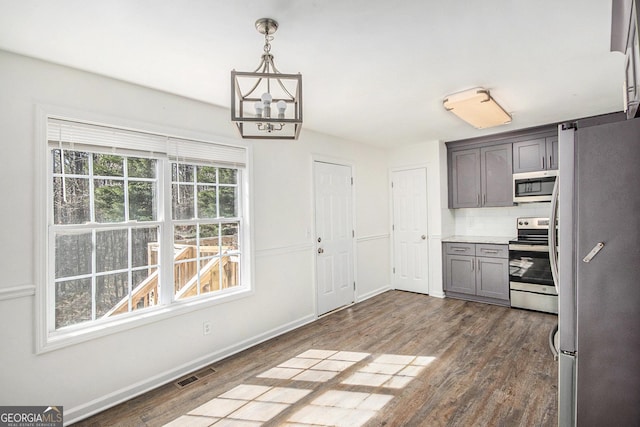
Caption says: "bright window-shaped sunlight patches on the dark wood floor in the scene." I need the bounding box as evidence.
[166,349,434,427]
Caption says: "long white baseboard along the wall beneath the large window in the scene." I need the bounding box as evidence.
[64,314,317,425]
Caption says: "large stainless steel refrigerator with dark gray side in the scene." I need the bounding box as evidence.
[557,115,640,427]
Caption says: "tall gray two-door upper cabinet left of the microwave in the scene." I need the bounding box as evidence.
[449,144,513,208]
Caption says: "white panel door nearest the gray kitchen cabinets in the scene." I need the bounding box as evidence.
[391,168,429,294]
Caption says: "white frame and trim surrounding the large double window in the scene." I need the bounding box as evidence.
[34,105,254,354]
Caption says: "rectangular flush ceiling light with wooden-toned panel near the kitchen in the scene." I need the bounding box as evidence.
[442,87,511,129]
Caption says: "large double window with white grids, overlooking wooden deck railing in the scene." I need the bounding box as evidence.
[44,119,249,348]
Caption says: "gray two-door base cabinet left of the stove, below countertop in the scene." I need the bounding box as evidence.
[443,243,509,305]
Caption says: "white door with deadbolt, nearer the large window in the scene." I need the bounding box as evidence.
[314,161,355,314]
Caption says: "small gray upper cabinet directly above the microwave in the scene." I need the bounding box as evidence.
[513,136,558,173]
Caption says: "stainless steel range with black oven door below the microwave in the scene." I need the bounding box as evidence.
[509,218,558,314]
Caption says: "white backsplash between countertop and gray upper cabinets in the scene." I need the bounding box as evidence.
[452,203,551,237]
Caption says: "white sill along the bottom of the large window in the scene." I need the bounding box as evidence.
[36,286,254,354]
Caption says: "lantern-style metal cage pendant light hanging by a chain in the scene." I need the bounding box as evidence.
[231,18,302,139]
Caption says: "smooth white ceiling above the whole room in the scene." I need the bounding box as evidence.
[0,0,624,147]
